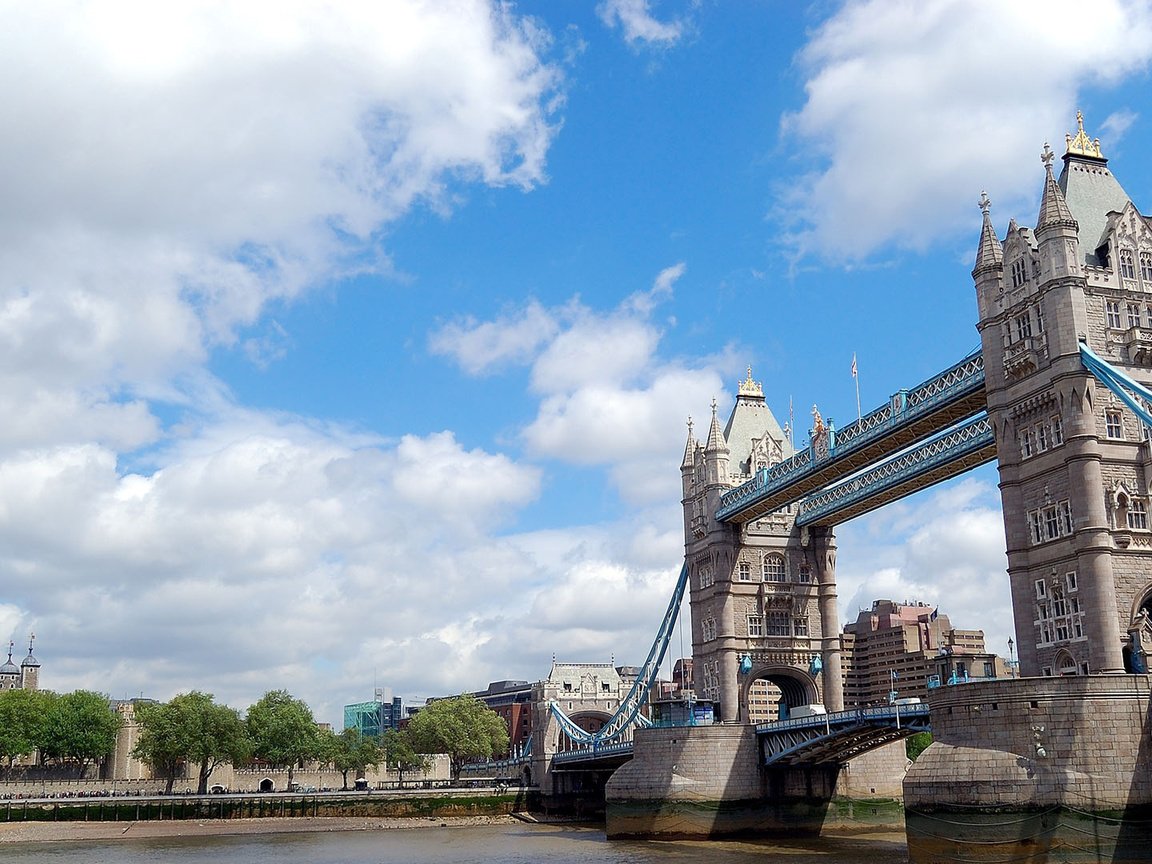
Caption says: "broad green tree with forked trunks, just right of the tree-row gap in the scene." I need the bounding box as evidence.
[132,690,251,795]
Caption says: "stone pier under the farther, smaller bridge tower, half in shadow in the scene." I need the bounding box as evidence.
[605,723,905,839]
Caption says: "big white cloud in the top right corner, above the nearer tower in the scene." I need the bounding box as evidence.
[778,0,1152,262]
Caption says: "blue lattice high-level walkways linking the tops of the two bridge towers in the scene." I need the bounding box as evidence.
[717,353,995,524]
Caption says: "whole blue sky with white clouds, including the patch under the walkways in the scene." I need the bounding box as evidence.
[0,0,1152,723]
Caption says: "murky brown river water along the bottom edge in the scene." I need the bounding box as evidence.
[0,825,908,864]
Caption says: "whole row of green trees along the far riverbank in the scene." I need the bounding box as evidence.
[0,690,508,795]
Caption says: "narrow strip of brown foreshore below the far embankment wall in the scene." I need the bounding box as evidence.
[0,816,517,843]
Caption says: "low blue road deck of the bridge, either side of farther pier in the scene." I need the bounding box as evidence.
[543,703,932,772]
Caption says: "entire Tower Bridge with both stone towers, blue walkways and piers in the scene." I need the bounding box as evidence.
[509,118,1152,861]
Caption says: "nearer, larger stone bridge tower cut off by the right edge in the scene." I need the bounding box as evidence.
[972,115,1152,675]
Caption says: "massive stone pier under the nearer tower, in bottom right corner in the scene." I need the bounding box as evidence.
[904,675,1152,864]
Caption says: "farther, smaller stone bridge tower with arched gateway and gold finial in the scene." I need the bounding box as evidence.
[681,369,843,722]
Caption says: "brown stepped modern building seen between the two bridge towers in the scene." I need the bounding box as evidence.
[843,600,1008,707]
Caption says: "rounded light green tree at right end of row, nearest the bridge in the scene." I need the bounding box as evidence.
[408,694,508,780]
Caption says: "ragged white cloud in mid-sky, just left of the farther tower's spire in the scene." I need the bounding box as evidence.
[430,267,740,503]
